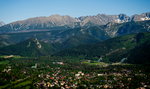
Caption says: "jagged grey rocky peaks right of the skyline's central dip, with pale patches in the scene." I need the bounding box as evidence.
[79,14,130,26]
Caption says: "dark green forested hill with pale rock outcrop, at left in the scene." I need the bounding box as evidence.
[0,39,56,56]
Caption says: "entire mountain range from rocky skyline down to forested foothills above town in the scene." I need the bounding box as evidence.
[0,13,150,63]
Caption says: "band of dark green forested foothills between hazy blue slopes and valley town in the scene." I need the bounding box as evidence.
[0,32,150,63]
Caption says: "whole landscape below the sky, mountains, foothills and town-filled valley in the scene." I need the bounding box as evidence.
[0,12,150,89]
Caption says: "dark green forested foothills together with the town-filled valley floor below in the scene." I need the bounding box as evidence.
[0,33,150,89]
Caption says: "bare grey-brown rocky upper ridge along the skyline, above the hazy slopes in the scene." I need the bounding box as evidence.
[0,12,150,33]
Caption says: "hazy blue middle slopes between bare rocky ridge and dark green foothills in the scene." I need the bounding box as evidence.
[0,21,150,46]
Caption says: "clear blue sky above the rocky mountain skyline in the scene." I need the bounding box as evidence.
[0,0,150,23]
